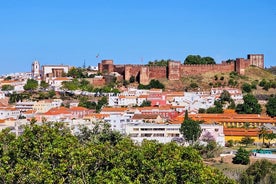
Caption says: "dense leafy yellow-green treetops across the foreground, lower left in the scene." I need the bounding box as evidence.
[0,122,234,183]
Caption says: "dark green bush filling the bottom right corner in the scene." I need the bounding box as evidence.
[240,159,276,183]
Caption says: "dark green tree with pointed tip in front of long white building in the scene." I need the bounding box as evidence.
[180,110,202,144]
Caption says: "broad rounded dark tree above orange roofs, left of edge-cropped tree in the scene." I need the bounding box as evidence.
[236,94,262,114]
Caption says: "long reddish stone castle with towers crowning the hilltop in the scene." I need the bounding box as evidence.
[98,54,264,84]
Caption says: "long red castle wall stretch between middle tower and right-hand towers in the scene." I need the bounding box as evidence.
[180,62,235,77]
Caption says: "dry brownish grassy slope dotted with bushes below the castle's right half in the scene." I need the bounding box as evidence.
[163,66,276,95]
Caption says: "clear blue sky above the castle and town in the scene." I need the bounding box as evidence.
[0,0,276,74]
